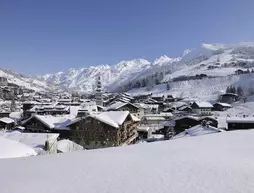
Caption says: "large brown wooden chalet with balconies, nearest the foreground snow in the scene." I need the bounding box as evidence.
[68,111,138,149]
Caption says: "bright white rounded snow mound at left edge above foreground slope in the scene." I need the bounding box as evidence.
[0,136,36,159]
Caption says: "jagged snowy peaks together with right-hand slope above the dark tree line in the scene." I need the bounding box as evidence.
[39,42,254,92]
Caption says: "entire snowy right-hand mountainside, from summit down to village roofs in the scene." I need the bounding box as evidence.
[129,42,254,101]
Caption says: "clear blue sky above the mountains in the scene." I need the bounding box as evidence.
[0,0,254,74]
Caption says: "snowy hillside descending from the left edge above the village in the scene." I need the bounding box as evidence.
[0,69,60,91]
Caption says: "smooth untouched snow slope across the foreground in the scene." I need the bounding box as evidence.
[0,130,254,193]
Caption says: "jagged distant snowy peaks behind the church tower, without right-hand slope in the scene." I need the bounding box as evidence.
[39,55,185,92]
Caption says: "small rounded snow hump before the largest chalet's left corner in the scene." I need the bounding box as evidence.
[57,139,84,153]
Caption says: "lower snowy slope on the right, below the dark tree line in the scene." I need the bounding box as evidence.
[128,73,254,101]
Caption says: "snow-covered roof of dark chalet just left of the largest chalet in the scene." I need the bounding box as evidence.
[22,115,75,129]
